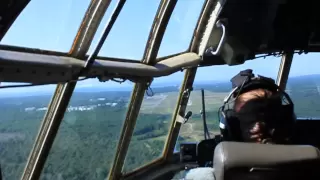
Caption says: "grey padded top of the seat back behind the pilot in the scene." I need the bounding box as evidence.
[213,142,320,180]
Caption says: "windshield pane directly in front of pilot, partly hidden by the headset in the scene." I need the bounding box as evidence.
[176,57,280,151]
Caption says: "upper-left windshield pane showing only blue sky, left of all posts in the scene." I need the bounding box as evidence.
[1,0,90,52]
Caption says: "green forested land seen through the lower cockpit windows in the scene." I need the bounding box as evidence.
[0,75,320,180]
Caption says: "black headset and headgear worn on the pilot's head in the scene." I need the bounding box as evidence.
[219,69,296,143]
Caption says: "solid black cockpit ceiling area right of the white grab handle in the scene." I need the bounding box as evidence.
[218,0,320,54]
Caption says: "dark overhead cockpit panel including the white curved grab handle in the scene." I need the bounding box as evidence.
[200,0,320,65]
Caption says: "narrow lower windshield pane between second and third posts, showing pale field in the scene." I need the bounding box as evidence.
[123,72,184,173]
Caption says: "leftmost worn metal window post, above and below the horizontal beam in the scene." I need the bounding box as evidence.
[22,0,111,179]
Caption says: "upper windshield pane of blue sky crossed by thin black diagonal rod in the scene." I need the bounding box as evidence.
[94,0,160,61]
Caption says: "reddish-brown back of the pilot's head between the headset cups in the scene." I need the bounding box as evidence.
[234,88,282,143]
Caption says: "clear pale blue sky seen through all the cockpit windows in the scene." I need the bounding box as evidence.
[0,0,320,93]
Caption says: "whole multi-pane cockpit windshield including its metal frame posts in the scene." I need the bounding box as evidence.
[0,0,320,180]
